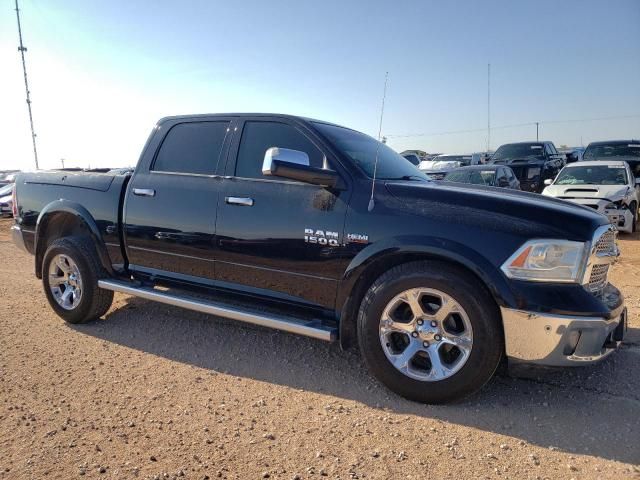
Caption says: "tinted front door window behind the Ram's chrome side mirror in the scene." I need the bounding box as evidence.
[235,121,325,180]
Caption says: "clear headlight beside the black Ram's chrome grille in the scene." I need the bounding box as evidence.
[502,240,588,283]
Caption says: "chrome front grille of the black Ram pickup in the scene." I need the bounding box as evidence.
[582,226,618,294]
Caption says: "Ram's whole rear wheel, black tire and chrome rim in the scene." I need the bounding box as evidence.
[42,237,113,323]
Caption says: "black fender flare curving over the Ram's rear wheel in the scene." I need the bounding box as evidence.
[34,199,113,278]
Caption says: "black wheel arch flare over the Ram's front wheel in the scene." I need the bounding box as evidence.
[336,239,514,349]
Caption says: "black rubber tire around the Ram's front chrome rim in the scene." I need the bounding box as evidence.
[357,261,504,404]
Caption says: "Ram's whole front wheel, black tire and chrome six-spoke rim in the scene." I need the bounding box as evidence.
[358,261,504,403]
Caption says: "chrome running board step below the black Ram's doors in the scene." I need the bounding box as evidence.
[98,280,337,342]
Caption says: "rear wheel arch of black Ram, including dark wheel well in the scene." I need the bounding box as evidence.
[34,199,113,278]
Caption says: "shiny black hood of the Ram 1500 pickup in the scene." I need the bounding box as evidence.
[386,182,609,241]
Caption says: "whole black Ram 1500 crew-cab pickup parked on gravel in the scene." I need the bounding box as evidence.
[12,114,626,403]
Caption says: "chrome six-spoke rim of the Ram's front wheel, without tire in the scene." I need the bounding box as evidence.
[380,288,473,382]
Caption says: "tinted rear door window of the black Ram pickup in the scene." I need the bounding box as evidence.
[152,121,229,175]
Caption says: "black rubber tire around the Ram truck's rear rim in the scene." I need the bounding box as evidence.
[42,237,113,323]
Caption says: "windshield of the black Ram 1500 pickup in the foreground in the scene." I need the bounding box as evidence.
[313,122,429,181]
